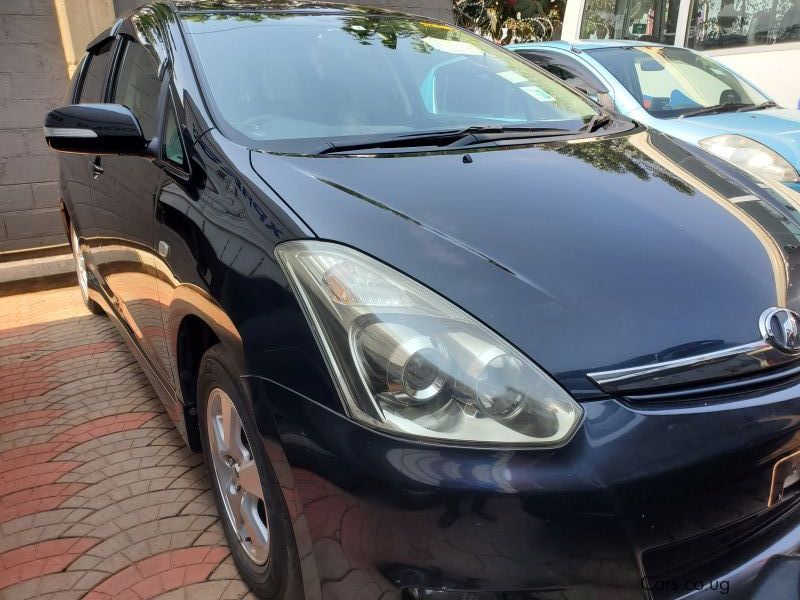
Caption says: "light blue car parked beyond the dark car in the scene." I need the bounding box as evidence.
[509,40,800,191]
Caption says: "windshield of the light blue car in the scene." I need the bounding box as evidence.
[587,46,769,118]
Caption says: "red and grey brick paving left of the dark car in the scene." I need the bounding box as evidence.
[0,288,252,600]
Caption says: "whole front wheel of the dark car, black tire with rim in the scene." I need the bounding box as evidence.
[197,344,303,600]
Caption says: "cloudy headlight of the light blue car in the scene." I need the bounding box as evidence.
[700,133,798,182]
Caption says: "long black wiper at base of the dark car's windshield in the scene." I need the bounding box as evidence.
[317,125,574,154]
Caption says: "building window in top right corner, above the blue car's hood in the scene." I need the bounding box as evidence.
[686,0,800,50]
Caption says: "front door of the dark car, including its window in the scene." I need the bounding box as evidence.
[92,36,172,381]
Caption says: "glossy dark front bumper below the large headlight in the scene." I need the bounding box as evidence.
[252,378,800,600]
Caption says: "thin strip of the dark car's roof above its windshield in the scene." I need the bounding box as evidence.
[163,0,412,20]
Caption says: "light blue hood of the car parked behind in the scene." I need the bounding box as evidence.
[653,108,800,170]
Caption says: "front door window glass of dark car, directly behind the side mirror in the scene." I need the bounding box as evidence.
[114,42,161,140]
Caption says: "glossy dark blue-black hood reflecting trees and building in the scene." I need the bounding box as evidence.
[251,130,800,397]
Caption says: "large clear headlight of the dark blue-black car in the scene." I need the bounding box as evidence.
[276,241,582,446]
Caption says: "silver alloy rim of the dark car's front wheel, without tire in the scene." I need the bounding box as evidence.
[206,388,270,565]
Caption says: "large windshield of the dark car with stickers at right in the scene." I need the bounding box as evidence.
[181,12,597,149]
